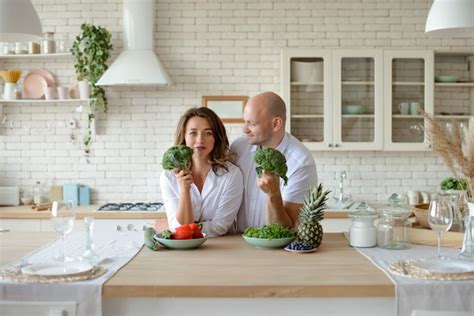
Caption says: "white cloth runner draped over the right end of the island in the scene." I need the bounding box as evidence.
[355,245,474,316]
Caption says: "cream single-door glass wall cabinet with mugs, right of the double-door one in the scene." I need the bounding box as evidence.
[384,51,433,151]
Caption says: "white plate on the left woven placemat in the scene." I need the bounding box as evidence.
[21,262,94,276]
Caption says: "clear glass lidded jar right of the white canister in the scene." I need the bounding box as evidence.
[377,193,411,249]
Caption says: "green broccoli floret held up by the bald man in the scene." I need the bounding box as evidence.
[254,148,288,185]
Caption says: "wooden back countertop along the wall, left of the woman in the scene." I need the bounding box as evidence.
[0,205,166,219]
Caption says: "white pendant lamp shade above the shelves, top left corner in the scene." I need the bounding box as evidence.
[0,0,43,42]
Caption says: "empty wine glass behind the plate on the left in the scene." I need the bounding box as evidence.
[51,201,75,262]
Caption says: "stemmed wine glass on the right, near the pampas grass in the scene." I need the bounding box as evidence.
[428,194,453,260]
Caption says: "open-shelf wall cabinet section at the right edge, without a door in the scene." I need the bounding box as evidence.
[434,51,474,132]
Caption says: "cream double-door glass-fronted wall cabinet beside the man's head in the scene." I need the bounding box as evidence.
[281,49,383,150]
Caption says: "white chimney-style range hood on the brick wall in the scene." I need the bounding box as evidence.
[97,0,173,86]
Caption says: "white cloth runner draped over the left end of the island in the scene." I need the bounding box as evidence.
[0,231,143,316]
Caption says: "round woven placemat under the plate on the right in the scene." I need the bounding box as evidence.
[388,260,474,281]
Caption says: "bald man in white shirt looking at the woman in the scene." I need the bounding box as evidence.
[231,92,317,232]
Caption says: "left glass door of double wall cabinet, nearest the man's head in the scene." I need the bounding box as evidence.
[282,49,332,150]
